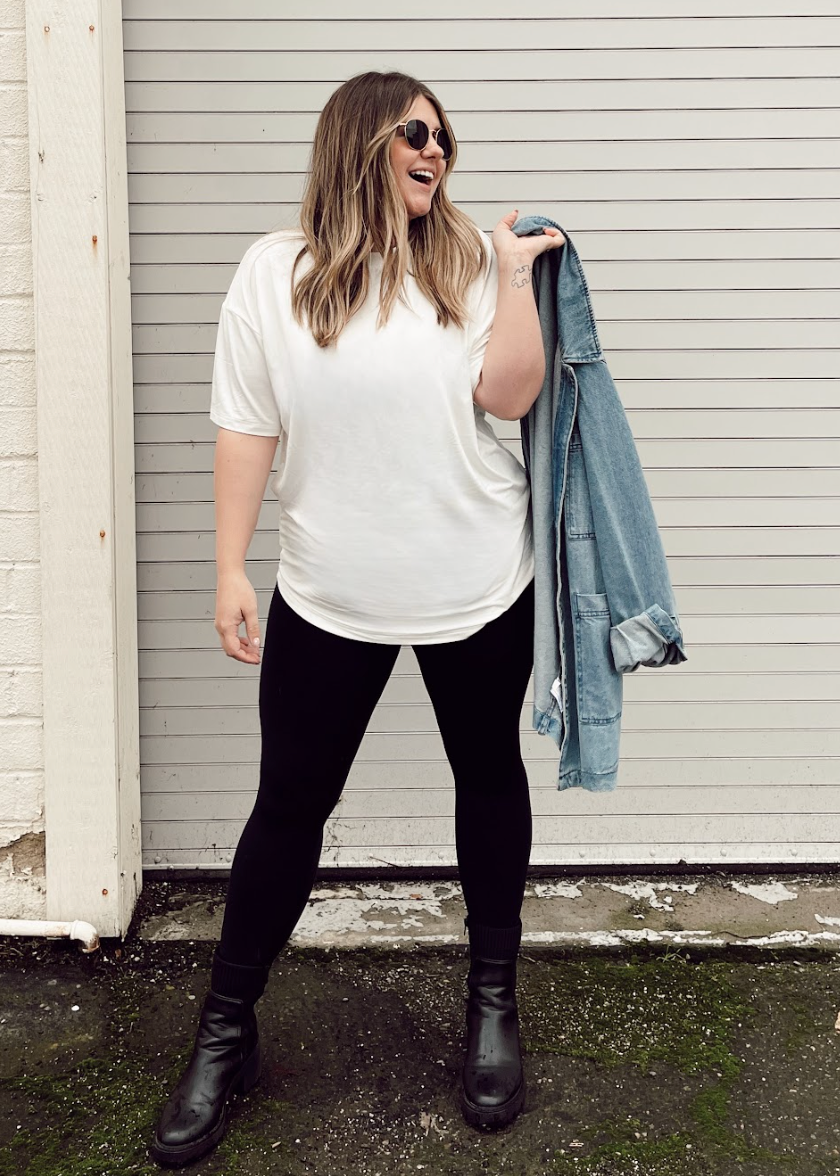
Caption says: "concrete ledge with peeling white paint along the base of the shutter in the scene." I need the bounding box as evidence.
[136,873,840,951]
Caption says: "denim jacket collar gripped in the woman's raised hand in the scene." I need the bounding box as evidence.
[513,215,604,363]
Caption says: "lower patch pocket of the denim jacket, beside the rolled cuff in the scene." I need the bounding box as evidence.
[574,592,624,723]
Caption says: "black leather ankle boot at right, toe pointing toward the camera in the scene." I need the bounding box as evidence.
[461,918,525,1129]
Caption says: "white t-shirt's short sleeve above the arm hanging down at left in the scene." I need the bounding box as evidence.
[209,300,281,436]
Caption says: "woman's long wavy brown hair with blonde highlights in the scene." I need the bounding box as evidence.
[292,71,486,347]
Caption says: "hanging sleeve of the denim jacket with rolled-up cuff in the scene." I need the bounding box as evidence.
[575,358,687,674]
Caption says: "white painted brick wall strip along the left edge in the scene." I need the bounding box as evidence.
[0,0,46,918]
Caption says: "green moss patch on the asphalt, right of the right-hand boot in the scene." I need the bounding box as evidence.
[534,951,796,1176]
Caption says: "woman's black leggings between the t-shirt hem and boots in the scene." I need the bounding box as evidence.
[219,580,534,965]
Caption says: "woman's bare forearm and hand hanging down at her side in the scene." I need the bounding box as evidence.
[213,428,279,664]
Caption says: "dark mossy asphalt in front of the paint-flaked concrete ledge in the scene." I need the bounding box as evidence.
[0,940,840,1176]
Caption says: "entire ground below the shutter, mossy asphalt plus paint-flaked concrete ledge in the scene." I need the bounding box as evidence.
[0,874,840,1176]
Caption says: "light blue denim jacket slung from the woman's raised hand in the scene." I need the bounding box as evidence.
[513,216,687,791]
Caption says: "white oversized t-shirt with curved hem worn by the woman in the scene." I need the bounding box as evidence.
[209,229,534,644]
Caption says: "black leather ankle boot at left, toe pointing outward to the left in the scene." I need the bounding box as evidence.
[149,957,268,1167]
